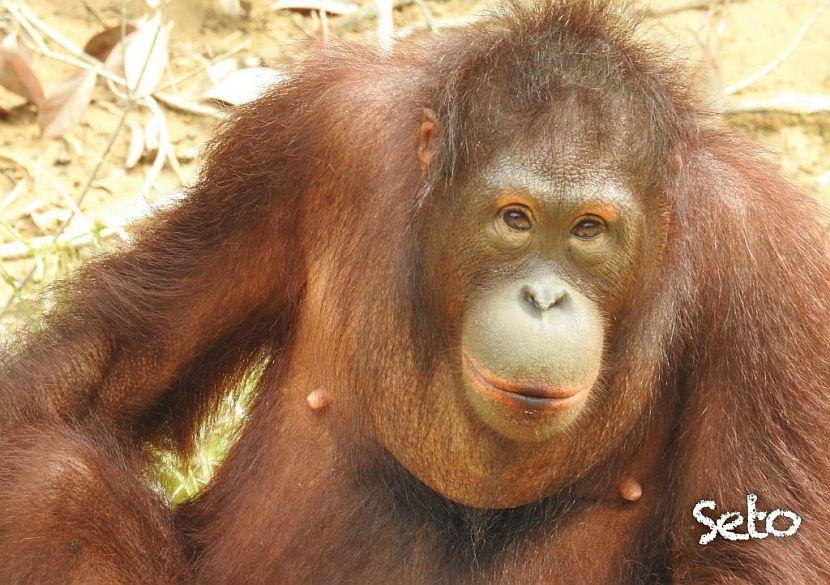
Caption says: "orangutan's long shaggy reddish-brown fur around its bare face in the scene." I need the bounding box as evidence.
[0,0,830,585]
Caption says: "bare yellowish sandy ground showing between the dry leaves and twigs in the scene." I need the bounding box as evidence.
[0,0,830,325]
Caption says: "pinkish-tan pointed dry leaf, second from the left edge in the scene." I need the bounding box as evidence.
[37,71,98,138]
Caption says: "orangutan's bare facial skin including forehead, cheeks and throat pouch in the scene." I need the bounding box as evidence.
[373,113,657,508]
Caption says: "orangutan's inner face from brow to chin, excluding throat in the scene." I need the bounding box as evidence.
[461,160,633,441]
